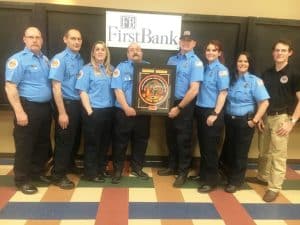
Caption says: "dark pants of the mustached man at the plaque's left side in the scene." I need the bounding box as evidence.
[112,108,150,171]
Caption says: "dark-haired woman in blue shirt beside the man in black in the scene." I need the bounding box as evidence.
[220,52,270,193]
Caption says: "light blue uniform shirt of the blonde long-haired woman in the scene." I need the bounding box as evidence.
[75,63,115,108]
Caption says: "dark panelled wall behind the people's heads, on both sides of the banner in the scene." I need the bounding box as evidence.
[0,3,300,105]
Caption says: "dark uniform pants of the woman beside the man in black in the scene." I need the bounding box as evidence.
[220,115,254,186]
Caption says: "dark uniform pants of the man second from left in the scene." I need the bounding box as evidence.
[53,100,81,177]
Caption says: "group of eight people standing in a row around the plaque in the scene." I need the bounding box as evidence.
[5,27,300,202]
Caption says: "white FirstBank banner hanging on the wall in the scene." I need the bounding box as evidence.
[106,11,181,50]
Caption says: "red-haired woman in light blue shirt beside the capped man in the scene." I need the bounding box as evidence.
[195,40,229,192]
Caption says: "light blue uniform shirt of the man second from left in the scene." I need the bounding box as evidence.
[49,48,83,100]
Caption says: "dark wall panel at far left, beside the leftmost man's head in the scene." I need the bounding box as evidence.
[0,6,32,104]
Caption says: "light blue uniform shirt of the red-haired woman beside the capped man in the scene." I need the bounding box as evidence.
[196,59,229,108]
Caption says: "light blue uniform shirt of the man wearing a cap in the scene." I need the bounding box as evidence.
[167,51,203,100]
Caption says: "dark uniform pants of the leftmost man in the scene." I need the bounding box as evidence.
[13,98,52,186]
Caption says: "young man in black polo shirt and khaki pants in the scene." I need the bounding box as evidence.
[248,40,300,202]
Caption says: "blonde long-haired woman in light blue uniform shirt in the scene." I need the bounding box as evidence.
[75,41,115,182]
